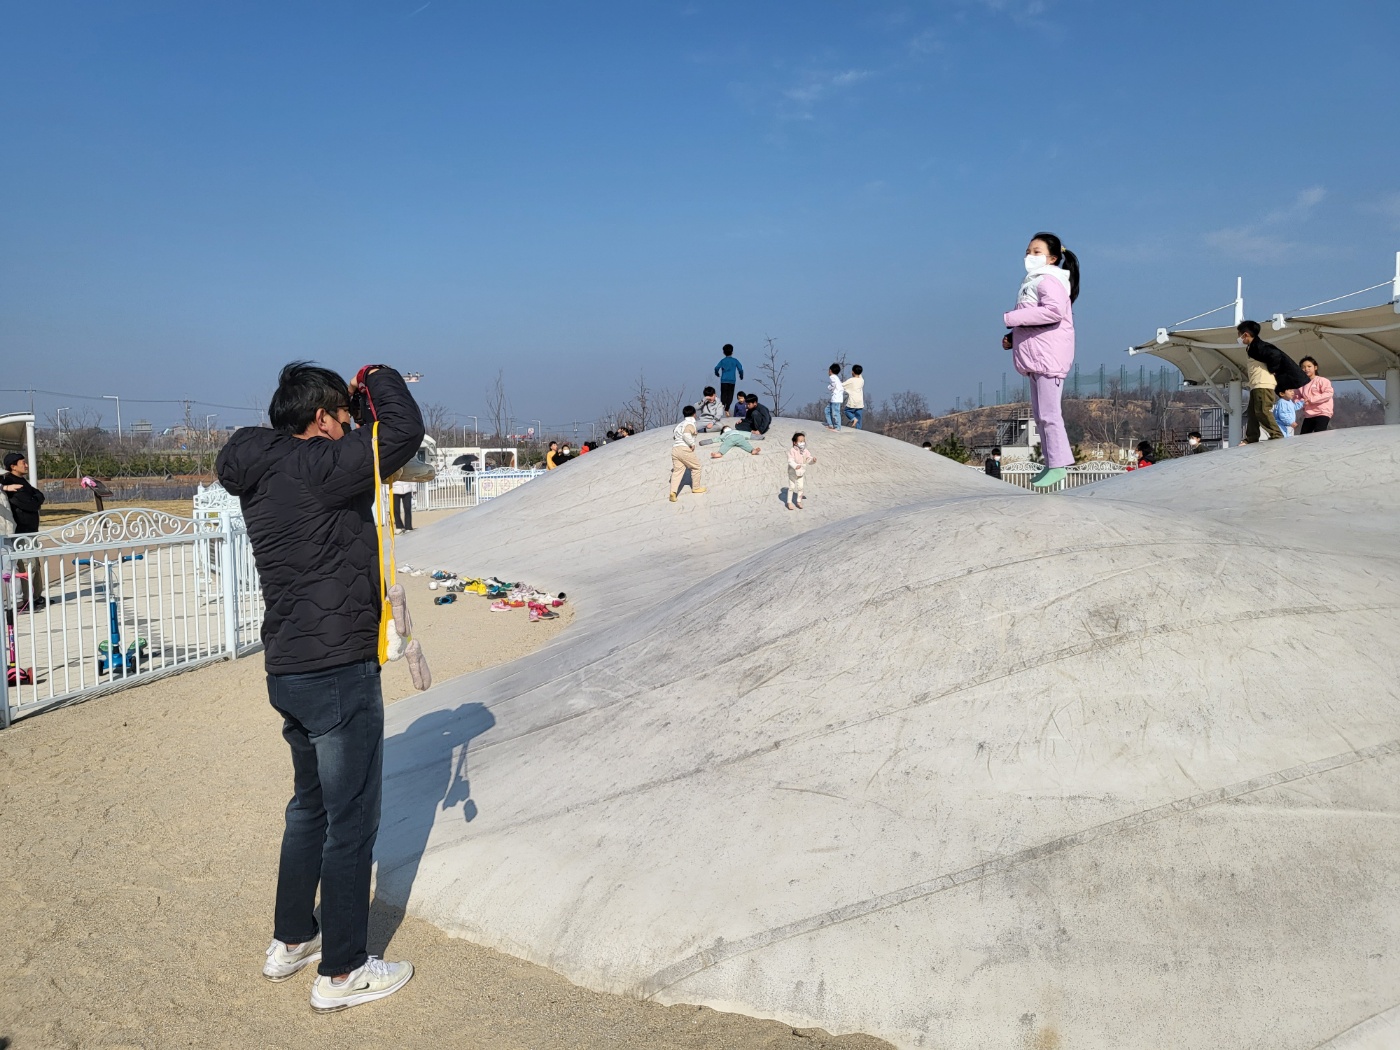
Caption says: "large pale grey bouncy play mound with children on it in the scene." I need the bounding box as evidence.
[379,421,1400,1050]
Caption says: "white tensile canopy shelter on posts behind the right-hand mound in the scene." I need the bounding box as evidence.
[1128,252,1400,445]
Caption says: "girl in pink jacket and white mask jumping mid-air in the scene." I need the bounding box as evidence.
[1002,234,1079,489]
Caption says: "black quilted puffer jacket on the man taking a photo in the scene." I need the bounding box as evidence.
[216,368,423,675]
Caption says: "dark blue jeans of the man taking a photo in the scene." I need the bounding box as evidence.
[267,659,384,976]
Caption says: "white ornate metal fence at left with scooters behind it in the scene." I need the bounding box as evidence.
[0,510,263,728]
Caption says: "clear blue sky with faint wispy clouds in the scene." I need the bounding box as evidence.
[0,0,1400,434]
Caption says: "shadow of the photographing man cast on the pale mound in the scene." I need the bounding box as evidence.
[370,704,496,956]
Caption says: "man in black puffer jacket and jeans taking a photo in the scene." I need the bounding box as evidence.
[217,361,423,1011]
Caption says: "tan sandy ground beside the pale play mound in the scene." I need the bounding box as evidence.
[0,511,888,1050]
